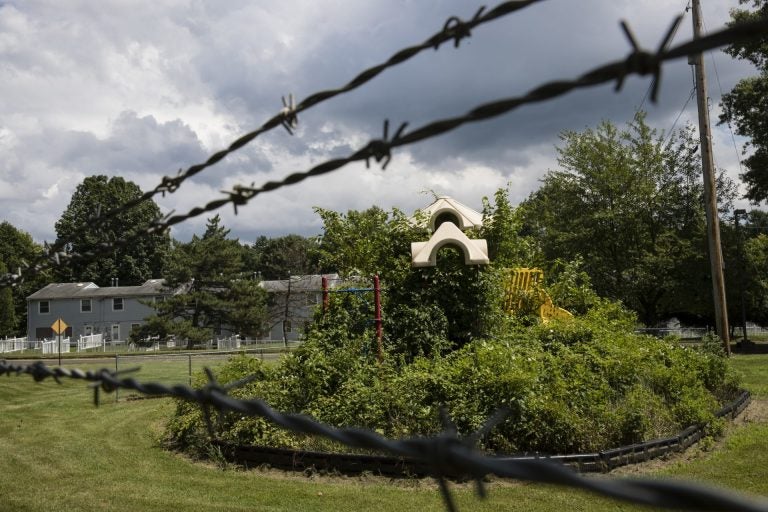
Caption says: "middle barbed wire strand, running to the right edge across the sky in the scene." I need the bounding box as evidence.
[0,16,768,286]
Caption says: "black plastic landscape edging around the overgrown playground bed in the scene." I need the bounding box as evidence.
[216,391,750,478]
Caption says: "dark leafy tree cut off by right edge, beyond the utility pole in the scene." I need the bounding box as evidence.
[720,0,768,203]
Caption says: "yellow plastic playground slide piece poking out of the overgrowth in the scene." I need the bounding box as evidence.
[504,267,573,323]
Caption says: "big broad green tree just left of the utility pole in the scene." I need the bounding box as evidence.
[523,112,733,325]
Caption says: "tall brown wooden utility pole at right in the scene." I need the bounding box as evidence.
[692,0,731,356]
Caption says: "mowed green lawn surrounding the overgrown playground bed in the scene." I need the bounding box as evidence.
[0,355,768,512]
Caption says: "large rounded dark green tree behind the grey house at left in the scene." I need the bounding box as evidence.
[56,175,170,286]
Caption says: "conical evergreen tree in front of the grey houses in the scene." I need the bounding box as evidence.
[148,215,266,345]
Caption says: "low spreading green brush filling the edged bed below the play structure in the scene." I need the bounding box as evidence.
[168,303,737,454]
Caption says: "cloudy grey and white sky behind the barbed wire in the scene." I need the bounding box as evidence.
[0,0,754,241]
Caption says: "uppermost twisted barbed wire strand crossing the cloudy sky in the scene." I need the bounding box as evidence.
[19,0,544,276]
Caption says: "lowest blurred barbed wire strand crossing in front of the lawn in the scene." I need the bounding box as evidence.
[0,360,768,512]
